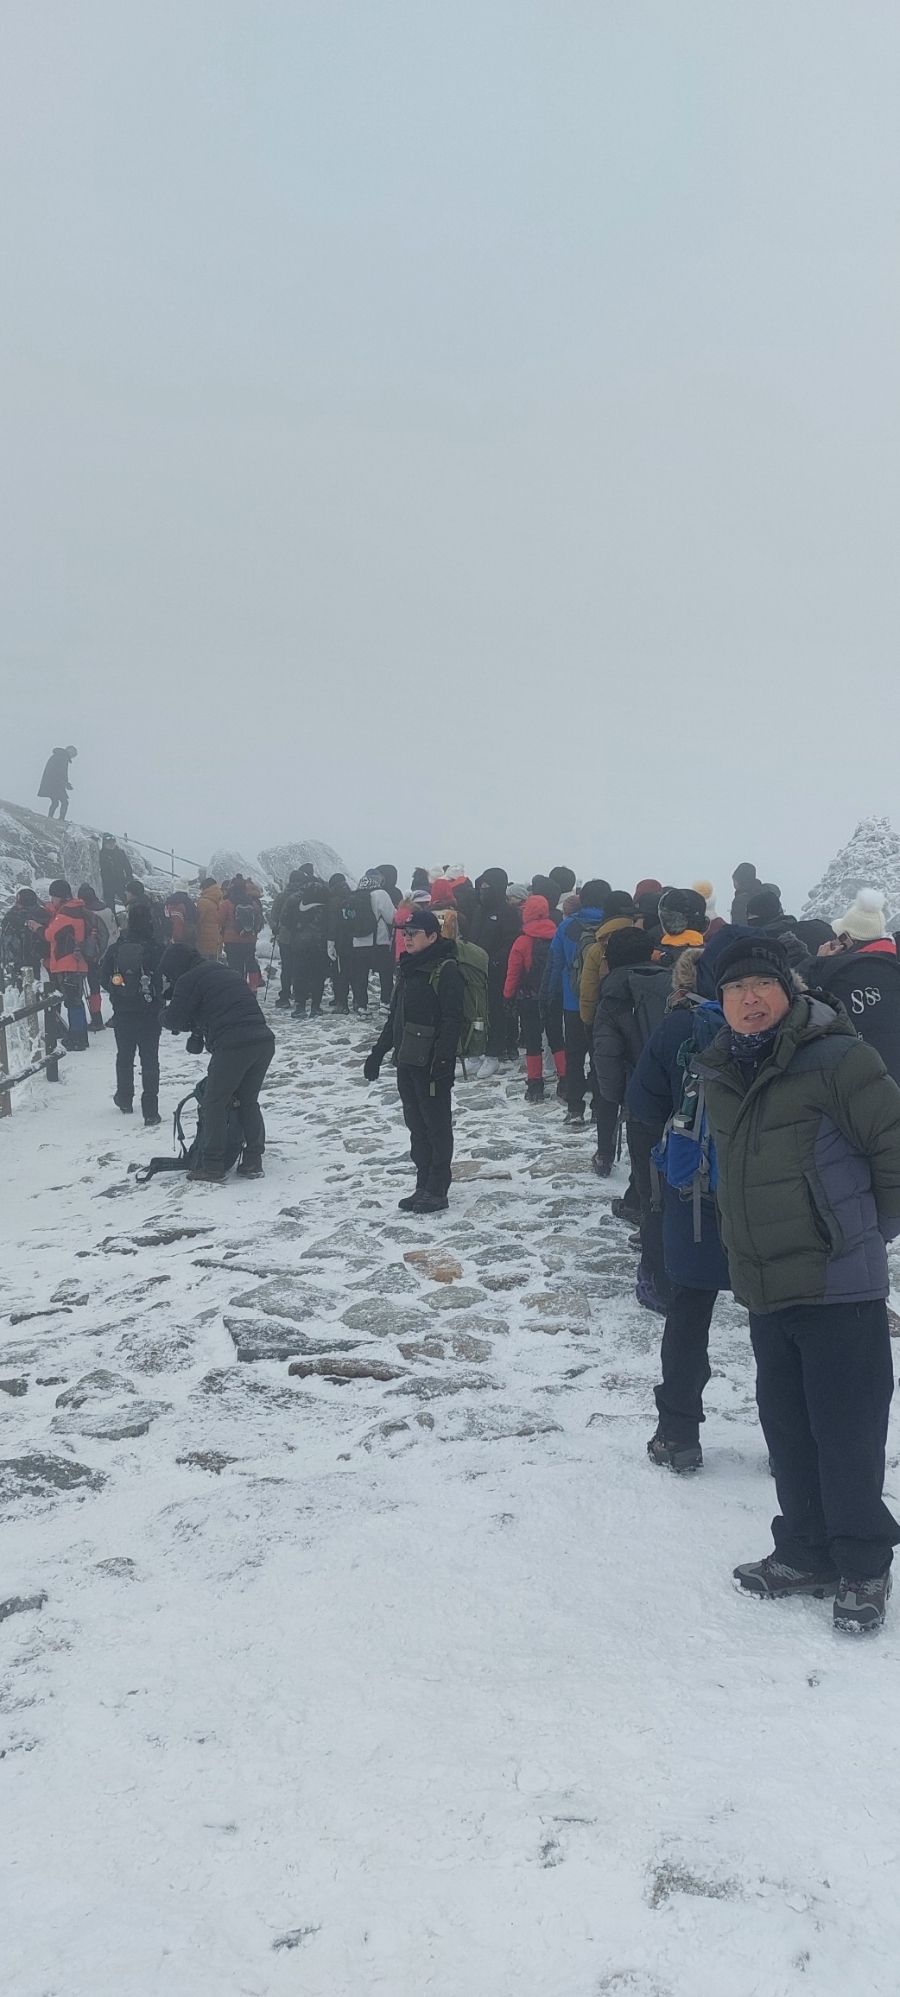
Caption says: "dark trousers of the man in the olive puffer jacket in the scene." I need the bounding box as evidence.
[750,1302,900,1582]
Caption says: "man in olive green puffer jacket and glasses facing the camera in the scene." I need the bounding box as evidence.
[692,939,900,1634]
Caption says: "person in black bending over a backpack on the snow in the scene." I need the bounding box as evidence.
[160,943,275,1184]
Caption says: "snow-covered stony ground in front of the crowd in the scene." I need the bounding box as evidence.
[0,986,900,1997]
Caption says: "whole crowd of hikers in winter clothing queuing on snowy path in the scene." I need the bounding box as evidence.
[0,837,900,1634]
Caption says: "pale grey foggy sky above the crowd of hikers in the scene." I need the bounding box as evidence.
[0,0,900,905]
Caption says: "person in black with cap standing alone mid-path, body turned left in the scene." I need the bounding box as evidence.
[363,909,465,1214]
